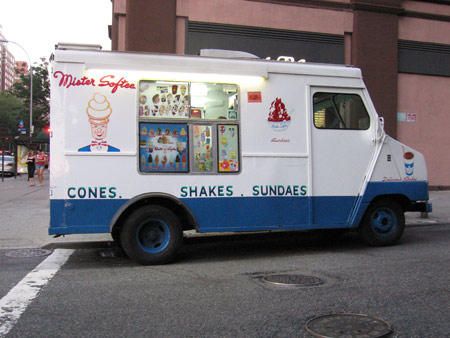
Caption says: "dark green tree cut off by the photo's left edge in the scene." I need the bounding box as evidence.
[0,92,26,135]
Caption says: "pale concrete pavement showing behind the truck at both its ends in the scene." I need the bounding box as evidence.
[0,176,450,249]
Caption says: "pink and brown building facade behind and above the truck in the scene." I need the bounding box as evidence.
[110,0,450,188]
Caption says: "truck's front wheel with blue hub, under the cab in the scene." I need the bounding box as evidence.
[359,200,405,246]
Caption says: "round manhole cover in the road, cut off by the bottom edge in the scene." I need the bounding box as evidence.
[305,313,392,338]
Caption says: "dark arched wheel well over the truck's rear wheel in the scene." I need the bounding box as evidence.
[111,196,196,238]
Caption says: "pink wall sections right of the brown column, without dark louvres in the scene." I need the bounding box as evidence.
[397,1,450,187]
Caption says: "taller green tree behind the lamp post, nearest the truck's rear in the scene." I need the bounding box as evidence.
[10,59,50,135]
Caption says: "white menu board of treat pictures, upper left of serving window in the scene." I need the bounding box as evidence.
[139,81,190,118]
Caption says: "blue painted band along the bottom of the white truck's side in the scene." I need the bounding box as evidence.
[49,181,428,234]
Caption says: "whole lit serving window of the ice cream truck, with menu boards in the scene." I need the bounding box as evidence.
[138,80,240,174]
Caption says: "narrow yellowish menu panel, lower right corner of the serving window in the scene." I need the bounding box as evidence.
[217,124,239,172]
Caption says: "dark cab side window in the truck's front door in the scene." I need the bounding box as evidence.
[313,93,370,130]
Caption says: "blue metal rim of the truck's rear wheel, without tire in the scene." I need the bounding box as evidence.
[136,219,170,254]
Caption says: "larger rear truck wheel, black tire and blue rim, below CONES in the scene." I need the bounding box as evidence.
[120,205,183,265]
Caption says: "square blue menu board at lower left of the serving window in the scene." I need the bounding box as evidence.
[139,122,189,172]
